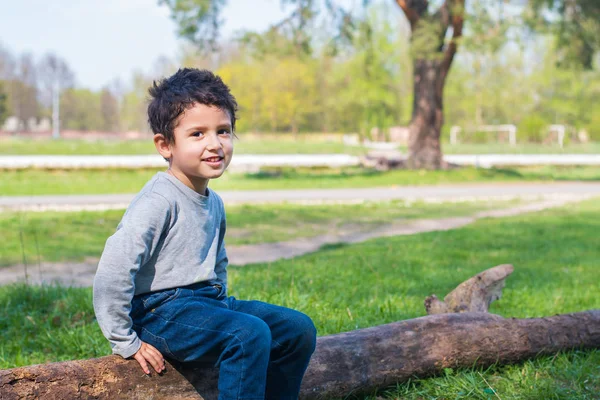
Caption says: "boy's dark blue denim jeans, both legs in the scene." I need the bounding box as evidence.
[131,283,316,400]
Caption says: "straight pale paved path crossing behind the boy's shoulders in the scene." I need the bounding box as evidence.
[0,182,600,212]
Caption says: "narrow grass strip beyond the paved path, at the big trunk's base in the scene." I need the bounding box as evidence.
[0,166,600,196]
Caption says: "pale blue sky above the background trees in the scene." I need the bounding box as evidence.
[0,0,355,90]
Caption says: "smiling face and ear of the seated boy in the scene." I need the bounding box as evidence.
[154,103,233,194]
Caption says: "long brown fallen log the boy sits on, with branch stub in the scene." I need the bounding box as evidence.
[0,265,600,399]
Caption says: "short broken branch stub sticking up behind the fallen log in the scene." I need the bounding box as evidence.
[425,264,514,315]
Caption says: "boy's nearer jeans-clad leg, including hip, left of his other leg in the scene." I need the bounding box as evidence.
[131,286,271,400]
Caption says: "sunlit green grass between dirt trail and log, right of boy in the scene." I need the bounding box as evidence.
[231,199,600,334]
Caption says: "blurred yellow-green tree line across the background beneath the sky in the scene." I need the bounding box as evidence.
[0,2,600,141]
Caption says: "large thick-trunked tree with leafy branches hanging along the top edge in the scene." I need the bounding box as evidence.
[161,0,600,168]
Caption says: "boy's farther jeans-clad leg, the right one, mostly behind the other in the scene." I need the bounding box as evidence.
[228,297,317,399]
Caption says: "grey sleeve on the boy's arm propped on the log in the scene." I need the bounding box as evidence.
[93,193,171,358]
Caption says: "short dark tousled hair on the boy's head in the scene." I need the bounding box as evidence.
[148,68,237,143]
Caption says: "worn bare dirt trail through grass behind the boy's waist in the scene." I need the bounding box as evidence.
[0,195,593,286]
